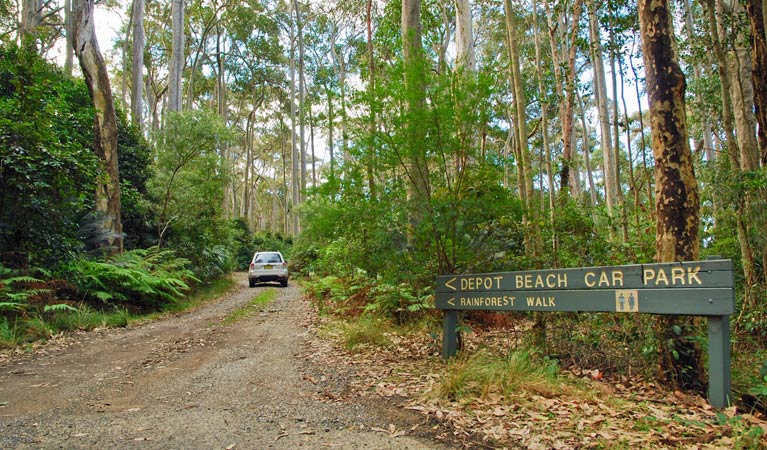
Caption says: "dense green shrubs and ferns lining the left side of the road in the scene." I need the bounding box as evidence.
[0,48,291,348]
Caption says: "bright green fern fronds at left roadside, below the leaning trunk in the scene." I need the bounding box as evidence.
[67,247,198,309]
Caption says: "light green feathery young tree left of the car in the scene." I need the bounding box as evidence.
[148,111,237,280]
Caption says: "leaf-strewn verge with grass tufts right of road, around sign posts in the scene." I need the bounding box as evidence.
[302,272,766,449]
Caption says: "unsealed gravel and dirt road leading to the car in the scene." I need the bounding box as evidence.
[0,274,446,449]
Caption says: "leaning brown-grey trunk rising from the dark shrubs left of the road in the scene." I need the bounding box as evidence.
[74,0,123,254]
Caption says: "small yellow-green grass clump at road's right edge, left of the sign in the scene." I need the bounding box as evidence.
[321,316,392,352]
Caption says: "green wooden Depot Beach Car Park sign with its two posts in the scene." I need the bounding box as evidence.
[436,259,735,408]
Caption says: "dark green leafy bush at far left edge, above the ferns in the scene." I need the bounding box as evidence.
[0,44,100,266]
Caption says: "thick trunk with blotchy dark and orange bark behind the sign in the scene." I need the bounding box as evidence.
[639,0,705,388]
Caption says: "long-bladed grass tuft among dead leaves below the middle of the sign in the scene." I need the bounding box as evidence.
[432,350,572,400]
